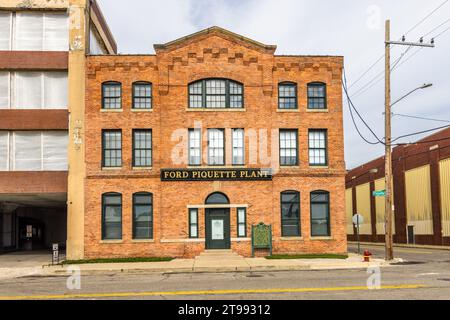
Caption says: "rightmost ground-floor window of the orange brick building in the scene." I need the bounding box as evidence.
[311,191,330,237]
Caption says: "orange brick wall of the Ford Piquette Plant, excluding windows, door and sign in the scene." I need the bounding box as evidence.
[84,28,347,258]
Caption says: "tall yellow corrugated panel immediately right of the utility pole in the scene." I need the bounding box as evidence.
[405,165,433,235]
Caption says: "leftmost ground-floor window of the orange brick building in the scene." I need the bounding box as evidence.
[102,193,122,240]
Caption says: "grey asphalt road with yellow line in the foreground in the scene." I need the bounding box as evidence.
[0,245,450,301]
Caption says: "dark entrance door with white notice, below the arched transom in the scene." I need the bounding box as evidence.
[205,209,231,249]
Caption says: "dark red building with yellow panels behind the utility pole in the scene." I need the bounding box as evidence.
[346,129,450,245]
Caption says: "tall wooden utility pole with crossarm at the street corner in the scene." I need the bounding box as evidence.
[384,20,434,261]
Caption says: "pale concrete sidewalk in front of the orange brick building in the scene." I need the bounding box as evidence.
[42,254,390,275]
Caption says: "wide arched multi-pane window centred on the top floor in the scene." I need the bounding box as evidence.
[189,79,244,109]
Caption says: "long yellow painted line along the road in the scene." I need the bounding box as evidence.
[0,284,426,300]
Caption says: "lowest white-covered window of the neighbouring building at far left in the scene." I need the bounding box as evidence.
[0,131,68,171]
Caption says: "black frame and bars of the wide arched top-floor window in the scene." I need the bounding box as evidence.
[188,78,245,110]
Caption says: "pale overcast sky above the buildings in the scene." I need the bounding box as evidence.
[98,0,450,169]
